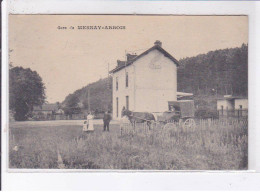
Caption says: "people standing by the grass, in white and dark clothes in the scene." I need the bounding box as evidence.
[83,111,112,132]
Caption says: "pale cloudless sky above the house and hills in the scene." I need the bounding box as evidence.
[9,15,248,103]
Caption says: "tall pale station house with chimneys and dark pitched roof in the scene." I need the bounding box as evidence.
[110,41,178,119]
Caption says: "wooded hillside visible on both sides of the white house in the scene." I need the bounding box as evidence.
[62,44,248,112]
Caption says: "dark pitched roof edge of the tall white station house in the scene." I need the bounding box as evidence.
[109,45,179,73]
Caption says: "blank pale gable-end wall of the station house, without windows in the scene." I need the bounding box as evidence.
[134,50,177,112]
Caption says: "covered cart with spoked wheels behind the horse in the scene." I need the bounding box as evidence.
[156,100,196,129]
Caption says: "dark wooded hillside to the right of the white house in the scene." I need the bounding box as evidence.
[178,44,248,96]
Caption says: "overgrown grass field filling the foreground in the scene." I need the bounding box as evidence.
[9,121,248,170]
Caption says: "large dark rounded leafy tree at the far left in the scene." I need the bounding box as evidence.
[9,67,46,121]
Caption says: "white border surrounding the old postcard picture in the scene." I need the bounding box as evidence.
[2,0,260,190]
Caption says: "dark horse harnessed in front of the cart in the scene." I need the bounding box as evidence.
[122,110,155,130]
